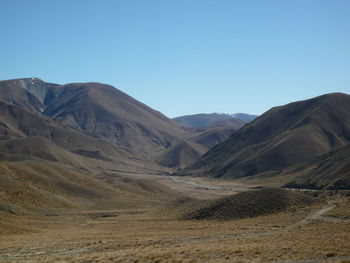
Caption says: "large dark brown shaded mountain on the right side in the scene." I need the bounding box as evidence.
[183,93,350,182]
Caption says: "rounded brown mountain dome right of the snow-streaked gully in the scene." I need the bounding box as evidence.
[44,83,186,155]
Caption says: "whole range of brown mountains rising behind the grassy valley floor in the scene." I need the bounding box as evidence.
[0,78,350,200]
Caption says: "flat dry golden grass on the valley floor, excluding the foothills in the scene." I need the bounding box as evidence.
[0,176,350,263]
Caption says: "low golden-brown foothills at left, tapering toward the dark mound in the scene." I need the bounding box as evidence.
[0,160,179,214]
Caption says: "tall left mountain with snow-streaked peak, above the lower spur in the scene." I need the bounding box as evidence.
[0,78,188,159]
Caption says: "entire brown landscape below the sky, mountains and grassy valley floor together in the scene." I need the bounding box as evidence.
[0,78,350,263]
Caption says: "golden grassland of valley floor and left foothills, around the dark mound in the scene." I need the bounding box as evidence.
[0,163,350,263]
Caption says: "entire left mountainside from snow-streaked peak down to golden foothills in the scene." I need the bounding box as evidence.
[0,78,188,214]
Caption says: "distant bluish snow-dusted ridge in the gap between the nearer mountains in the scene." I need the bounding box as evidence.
[173,113,256,129]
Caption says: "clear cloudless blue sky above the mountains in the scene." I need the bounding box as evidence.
[0,0,350,117]
